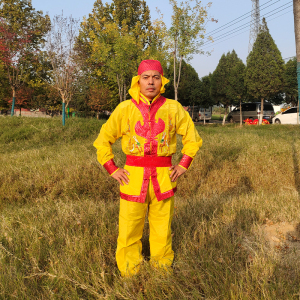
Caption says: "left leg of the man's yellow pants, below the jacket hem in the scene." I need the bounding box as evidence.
[116,199,148,276]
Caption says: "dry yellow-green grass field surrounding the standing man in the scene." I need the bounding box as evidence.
[0,117,300,299]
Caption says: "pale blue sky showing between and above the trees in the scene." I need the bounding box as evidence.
[32,0,296,78]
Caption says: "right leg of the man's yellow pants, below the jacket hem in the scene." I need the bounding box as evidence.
[148,182,174,267]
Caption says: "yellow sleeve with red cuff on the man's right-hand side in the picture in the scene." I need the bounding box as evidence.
[176,102,202,169]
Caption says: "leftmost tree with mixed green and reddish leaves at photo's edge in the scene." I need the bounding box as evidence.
[0,0,50,115]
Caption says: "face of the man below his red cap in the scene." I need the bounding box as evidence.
[139,70,161,100]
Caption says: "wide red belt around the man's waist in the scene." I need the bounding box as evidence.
[126,155,172,168]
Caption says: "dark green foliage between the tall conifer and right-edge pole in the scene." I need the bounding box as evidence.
[284,57,298,106]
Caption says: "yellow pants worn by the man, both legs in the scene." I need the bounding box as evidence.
[116,180,174,276]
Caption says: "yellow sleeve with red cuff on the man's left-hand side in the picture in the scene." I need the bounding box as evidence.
[93,104,122,174]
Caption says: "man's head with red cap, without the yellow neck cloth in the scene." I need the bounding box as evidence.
[138,60,163,100]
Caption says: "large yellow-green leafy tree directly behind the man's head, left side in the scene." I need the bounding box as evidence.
[77,0,156,102]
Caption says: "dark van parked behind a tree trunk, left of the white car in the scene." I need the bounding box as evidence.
[227,102,274,123]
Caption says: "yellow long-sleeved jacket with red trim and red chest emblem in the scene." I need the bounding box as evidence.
[94,94,202,202]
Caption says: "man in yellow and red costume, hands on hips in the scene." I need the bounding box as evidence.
[94,60,202,276]
